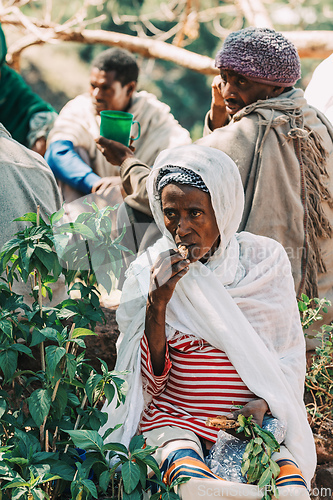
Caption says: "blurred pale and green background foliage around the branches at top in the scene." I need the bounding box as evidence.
[9,0,333,140]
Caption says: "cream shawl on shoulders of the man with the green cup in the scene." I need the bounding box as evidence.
[48,91,191,183]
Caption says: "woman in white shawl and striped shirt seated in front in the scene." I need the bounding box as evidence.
[103,145,315,500]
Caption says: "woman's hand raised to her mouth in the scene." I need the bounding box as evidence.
[148,249,190,308]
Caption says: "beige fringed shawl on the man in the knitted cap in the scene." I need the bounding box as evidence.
[197,89,333,308]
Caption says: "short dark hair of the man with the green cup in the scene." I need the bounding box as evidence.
[92,48,139,86]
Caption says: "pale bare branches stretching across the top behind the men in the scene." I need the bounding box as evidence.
[0,4,333,75]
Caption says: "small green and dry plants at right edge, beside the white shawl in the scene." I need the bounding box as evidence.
[298,294,333,428]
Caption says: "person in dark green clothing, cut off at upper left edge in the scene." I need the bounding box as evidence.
[0,26,57,156]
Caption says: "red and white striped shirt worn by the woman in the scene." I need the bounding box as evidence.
[140,332,256,441]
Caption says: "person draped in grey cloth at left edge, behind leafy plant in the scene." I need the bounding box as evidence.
[0,124,67,304]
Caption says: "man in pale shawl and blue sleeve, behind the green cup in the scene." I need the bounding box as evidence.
[46,48,191,202]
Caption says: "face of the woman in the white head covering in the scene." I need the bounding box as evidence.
[161,184,220,262]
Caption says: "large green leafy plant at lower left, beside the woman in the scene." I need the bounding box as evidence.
[0,204,169,500]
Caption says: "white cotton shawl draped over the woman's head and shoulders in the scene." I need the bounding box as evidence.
[102,145,316,485]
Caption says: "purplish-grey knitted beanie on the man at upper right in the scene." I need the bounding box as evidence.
[215,28,301,87]
